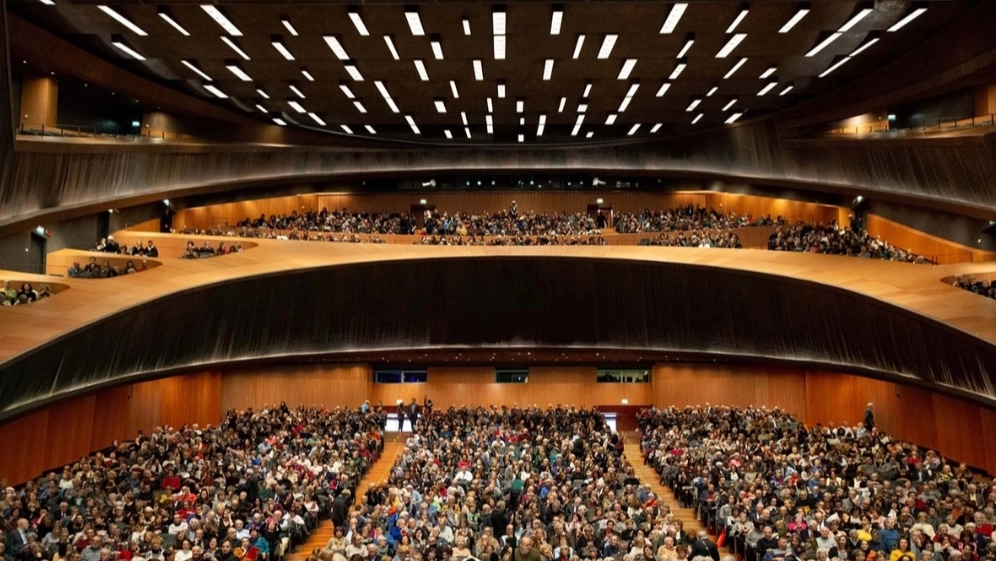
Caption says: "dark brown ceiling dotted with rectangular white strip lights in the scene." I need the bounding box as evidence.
[8,0,972,143]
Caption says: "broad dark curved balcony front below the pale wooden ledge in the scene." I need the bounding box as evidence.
[0,257,996,419]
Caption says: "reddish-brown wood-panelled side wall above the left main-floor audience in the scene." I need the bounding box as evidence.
[0,372,221,485]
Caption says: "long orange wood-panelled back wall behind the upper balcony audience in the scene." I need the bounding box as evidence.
[173,186,840,229]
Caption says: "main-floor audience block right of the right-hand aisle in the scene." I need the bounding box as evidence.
[639,405,996,561]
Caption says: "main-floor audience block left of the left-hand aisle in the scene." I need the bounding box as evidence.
[0,405,386,561]
